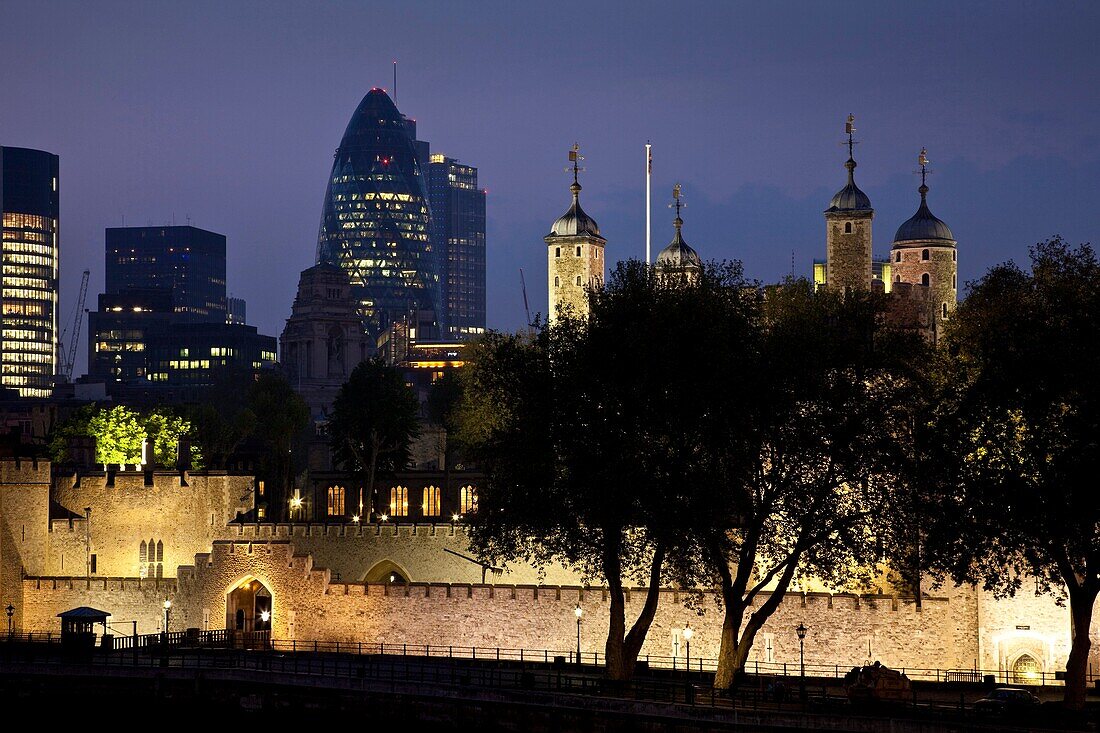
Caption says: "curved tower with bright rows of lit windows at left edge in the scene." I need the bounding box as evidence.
[0,147,59,397]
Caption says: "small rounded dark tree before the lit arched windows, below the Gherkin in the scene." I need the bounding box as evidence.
[328,359,420,514]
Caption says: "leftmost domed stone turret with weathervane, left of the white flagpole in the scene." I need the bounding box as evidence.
[543,145,607,324]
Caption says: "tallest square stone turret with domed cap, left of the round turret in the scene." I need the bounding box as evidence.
[825,114,875,291]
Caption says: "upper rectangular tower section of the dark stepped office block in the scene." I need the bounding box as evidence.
[106,227,226,322]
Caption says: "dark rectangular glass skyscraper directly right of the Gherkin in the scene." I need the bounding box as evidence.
[428,153,485,339]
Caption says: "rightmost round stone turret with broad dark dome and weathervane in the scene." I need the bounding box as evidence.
[890,149,958,330]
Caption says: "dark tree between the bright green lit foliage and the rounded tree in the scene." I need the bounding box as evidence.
[248,372,309,496]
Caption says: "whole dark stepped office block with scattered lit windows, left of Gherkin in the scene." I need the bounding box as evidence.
[83,227,276,396]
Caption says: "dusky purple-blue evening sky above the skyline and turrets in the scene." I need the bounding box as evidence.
[0,0,1100,373]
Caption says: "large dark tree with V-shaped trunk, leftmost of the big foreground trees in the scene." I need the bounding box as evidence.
[460,262,748,680]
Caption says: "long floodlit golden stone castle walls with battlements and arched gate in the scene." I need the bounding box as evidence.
[0,459,1100,679]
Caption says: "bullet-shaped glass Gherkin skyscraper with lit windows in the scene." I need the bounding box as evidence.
[317,88,440,337]
